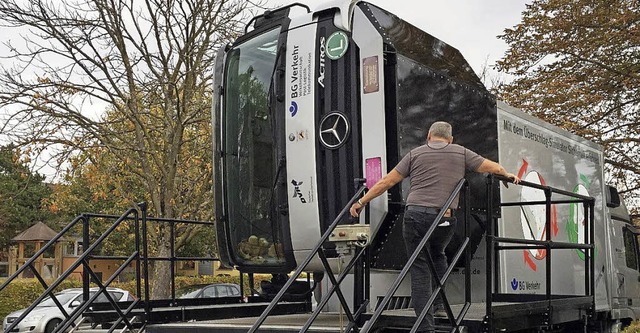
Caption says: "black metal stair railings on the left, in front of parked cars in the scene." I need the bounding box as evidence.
[0,203,228,332]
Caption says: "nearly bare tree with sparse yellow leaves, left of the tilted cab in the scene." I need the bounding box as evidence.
[0,0,262,298]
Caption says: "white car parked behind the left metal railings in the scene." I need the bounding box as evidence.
[2,288,134,333]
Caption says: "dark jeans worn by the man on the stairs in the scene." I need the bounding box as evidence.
[402,210,456,331]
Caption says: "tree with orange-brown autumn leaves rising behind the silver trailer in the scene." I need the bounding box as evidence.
[497,0,640,214]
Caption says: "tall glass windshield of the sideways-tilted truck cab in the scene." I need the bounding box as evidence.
[223,28,284,266]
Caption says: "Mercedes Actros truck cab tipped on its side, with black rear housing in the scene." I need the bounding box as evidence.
[214,2,498,272]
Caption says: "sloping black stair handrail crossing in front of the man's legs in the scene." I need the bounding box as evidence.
[360,178,470,333]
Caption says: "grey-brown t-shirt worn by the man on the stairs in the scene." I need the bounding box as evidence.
[395,141,484,208]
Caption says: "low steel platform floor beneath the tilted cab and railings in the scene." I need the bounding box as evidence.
[146,297,593,333]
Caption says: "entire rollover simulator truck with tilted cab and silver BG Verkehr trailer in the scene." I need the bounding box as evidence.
[213,1,640,331]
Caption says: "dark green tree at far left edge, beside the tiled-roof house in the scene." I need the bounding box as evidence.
[0,145,53,249]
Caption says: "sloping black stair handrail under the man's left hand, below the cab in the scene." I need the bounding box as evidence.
[248,185,366,333]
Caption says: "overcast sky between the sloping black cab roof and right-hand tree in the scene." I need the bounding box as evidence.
[267,0,531,83]
